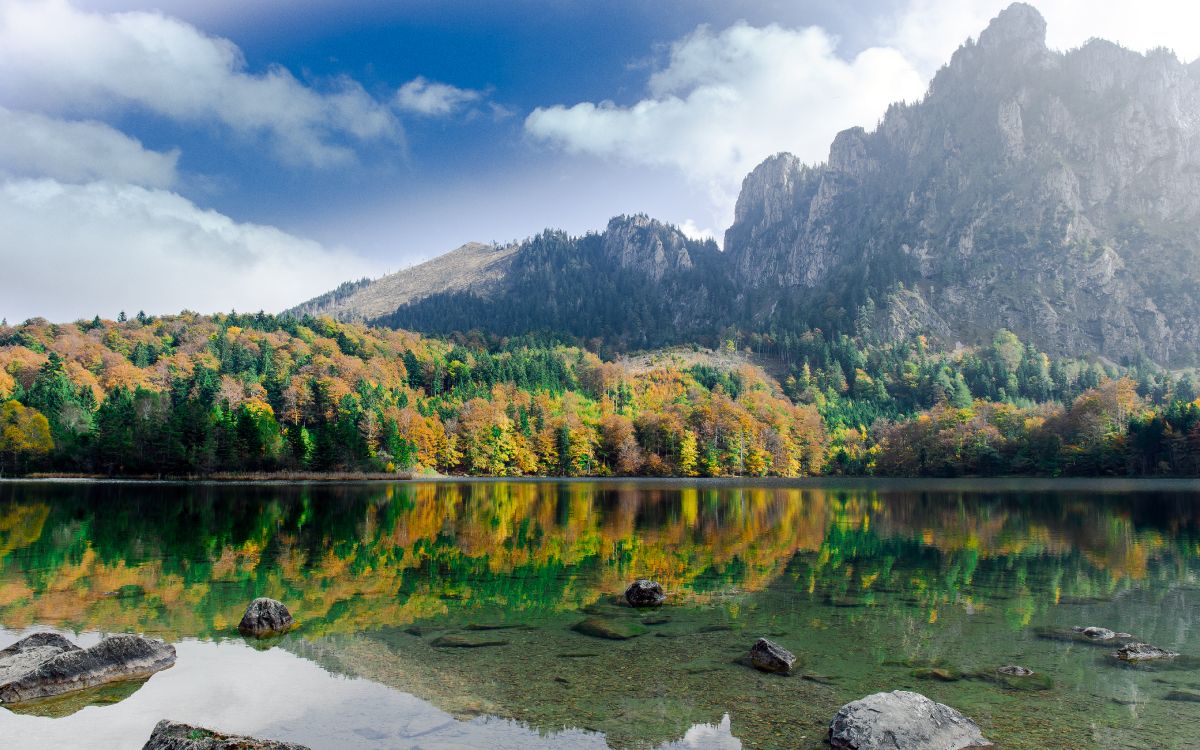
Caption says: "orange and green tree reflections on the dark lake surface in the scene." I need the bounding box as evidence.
[0,482,1200,635]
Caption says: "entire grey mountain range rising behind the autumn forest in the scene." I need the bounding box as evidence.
[295,4,1200,364]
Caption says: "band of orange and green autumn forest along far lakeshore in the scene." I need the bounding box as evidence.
[0,312,1200,476]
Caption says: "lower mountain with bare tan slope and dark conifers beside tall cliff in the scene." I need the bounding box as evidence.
[302,215,737,348]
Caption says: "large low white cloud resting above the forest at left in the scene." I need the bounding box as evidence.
[0,179,372,320]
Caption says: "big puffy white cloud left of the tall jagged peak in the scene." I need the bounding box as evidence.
[526,23,925,226]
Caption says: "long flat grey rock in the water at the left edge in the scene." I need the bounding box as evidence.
[0,632,175,703]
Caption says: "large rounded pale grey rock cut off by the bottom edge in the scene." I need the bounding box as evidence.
[829,690,991,750]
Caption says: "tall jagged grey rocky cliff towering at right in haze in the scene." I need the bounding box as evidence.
[725,4,1200,362]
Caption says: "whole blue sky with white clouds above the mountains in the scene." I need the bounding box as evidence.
[0,0,1200,323]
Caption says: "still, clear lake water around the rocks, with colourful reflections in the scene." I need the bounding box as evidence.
[0,481,1200,750]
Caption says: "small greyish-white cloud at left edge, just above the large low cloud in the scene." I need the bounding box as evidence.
[0,107,179,187]
